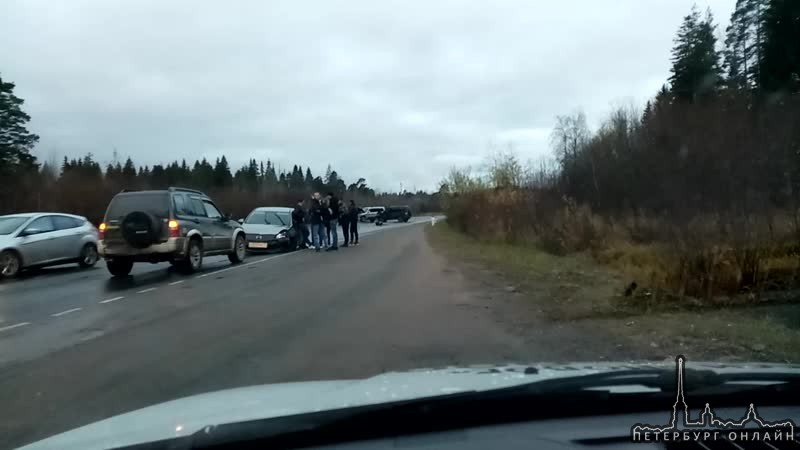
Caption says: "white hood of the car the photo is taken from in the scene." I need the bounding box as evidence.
[22,360,800,450]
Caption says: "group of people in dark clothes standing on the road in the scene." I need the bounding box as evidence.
[292,192,359,252]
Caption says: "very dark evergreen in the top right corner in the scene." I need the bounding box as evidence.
[761,0,800,92]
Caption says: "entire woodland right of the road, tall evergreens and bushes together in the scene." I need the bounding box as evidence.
[440,0,800,298]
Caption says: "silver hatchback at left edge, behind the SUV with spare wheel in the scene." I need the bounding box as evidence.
[0,213,98,278]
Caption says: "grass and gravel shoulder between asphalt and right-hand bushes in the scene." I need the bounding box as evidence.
[427,223,800,362]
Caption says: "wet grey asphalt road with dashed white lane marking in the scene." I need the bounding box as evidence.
[0,218,532,448]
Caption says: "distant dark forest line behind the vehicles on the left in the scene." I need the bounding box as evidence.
[0,78,439,223]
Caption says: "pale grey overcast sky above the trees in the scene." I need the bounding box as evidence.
[0,0,735,190]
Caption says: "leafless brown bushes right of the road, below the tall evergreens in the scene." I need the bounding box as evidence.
[440,88,800,304]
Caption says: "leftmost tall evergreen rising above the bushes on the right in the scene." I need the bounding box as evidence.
[669,7,722,101]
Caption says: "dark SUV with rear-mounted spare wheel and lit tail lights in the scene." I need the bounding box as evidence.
[97,188,247,276]
